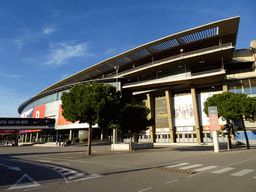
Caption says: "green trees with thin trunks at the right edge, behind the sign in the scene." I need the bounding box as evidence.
[204,92,256,149]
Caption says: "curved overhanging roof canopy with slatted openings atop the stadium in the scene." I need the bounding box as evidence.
[18,16,240,113]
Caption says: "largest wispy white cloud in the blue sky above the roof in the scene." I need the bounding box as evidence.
[46,43,94,65]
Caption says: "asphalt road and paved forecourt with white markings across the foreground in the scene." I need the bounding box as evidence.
[0,145,256,192]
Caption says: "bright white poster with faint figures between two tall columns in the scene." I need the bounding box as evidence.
[173,94,195,127]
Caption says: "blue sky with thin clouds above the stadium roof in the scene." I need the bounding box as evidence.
[0,0,256,117]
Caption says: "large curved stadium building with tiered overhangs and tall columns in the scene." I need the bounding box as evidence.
[18,16,256,143]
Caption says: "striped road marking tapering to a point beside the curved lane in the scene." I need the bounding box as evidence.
[51,166,101,183]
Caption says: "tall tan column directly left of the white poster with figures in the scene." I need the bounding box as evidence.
[165,90,176,143]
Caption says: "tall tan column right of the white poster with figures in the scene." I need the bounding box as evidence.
[191,86,202,143]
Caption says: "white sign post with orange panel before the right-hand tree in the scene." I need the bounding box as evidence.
[208,106,220,153]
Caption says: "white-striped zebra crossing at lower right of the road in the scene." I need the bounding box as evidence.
[165,163,256,179]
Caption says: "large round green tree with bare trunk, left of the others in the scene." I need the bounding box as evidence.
[61,82,116,155]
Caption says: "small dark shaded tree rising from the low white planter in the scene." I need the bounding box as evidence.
[118,104,153,150]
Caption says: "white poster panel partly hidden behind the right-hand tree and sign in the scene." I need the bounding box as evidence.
[198,91,226,127]
